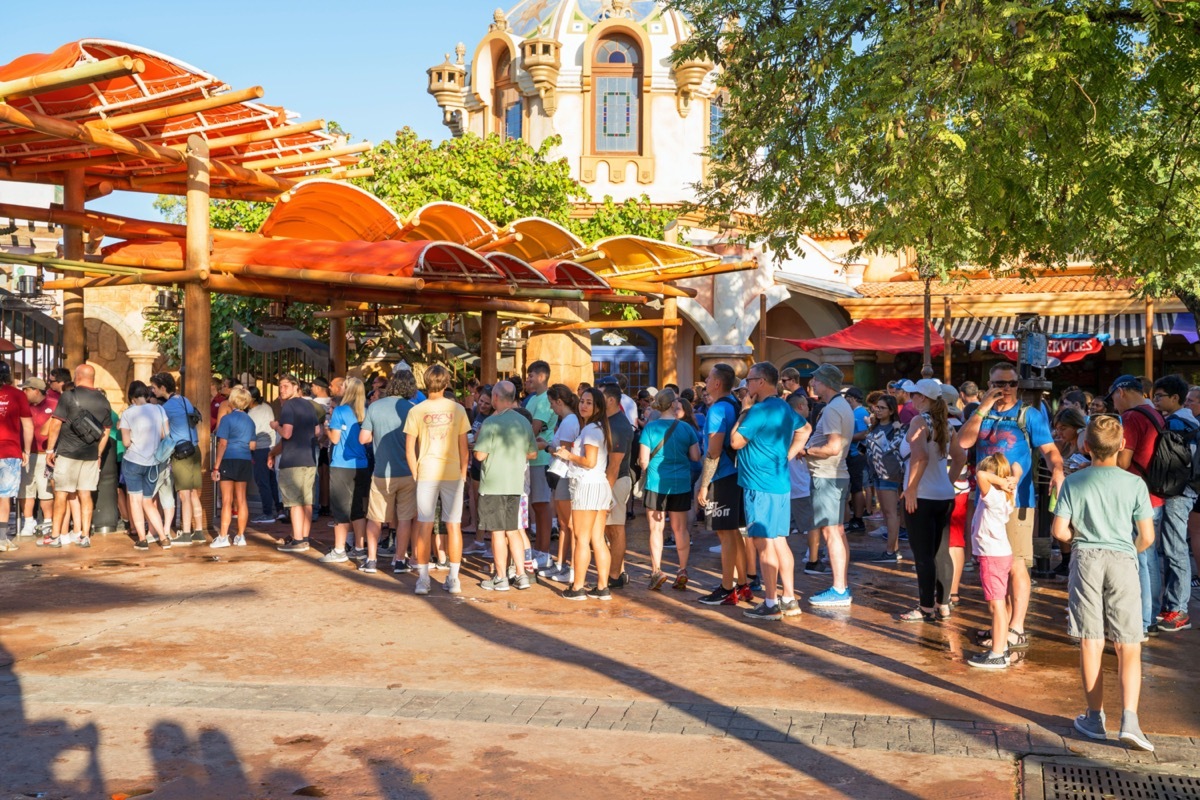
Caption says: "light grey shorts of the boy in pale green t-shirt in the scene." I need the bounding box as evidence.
[1067,547,1142,644]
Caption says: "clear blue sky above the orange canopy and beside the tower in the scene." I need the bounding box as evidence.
[0,0,516,218]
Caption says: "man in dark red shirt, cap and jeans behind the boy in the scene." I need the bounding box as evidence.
[1109,375,1165,632]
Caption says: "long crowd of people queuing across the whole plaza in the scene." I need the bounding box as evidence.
[0,361,1200,747]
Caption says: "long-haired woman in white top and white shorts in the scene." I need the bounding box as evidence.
[554,386,612,600]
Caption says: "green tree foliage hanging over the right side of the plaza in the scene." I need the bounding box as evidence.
[672,0,1200,311]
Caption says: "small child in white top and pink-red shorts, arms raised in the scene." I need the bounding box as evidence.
[967,453,1021,669]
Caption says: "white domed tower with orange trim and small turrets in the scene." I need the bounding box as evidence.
[430,0,720,204]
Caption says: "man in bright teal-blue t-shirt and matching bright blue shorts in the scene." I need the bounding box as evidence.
[730,361,809,621]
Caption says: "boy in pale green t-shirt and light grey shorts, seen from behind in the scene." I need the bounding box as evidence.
[1051,416,1154,752]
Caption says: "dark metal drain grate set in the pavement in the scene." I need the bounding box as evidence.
[1026,759,1200,800]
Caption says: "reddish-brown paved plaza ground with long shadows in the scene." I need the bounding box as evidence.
[0,513,1200,798]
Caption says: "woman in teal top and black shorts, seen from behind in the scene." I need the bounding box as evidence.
[637,389,700,591]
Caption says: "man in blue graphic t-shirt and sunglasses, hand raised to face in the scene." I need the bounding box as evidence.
[959,361,1063,646]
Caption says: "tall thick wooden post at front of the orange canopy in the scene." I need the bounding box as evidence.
[182,134,212,520]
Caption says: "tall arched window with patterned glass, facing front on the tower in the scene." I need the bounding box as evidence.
[592,36,642,155]
